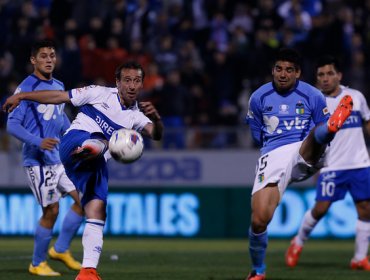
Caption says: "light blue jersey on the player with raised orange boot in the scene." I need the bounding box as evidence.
[247,81,329,154]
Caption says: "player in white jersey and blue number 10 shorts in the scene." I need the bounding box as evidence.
[285,56,370,271]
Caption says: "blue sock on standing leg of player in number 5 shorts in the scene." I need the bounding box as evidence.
[249,229,267,274]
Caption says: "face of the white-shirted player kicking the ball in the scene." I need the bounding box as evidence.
[116,69,143,106]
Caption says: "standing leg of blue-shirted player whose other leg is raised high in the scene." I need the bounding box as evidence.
[247,184,280,280]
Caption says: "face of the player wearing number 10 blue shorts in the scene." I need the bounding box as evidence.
[316,64,342,96]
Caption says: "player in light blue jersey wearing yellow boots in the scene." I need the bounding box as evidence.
[7,41,83,276]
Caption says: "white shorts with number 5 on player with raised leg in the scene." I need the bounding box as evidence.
[252,141,323,199]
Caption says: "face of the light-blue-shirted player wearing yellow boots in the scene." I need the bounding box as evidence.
[31,47,57,80]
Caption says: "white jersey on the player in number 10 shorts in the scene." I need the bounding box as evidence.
[321,86,370,172]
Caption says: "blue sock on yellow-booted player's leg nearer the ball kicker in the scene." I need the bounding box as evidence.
[54,208,83,253]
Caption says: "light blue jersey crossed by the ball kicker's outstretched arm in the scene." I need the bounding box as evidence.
[7,74,70,166]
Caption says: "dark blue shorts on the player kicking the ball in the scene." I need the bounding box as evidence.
[59,130,108,206]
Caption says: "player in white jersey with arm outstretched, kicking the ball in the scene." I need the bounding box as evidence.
[3,62,163,280]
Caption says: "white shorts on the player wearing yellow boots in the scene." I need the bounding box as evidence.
[24,164,76,207]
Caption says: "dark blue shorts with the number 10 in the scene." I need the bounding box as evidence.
[316,167,370,202]
